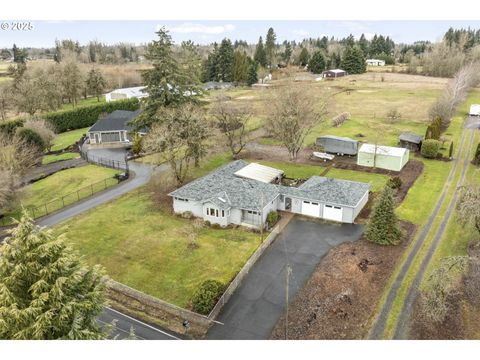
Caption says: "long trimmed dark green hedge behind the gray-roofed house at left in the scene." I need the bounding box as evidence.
[40,98,140,134]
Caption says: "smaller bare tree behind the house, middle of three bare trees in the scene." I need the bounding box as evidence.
[211,96,251,158]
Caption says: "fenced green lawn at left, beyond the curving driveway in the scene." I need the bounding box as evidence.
[7,165,118,218]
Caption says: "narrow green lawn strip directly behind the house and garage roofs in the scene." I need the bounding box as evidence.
[255,160,389,192]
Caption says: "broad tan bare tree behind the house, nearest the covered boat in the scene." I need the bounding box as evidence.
[266,83,327,161]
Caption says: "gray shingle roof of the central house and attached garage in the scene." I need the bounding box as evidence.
[169,160,370,211]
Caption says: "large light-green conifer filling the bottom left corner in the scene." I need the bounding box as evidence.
[0,213,105,340]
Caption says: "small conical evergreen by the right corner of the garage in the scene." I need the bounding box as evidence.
[365,186,401,245]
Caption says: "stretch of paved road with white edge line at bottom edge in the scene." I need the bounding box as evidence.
[98,308,184,340]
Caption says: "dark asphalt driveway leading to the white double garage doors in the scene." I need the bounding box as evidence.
[207,217,363,340]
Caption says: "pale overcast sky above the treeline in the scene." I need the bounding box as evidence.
[0,20,480,47]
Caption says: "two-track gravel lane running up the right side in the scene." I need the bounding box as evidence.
[369,118,480,339]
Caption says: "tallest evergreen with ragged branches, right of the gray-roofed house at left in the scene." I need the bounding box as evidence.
[133,27,200,128]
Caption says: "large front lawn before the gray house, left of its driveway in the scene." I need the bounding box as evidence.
[57,191,260,307]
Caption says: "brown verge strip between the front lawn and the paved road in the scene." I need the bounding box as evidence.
[107,280,211,339]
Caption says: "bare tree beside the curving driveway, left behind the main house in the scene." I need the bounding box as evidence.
[144,104,209,185]
